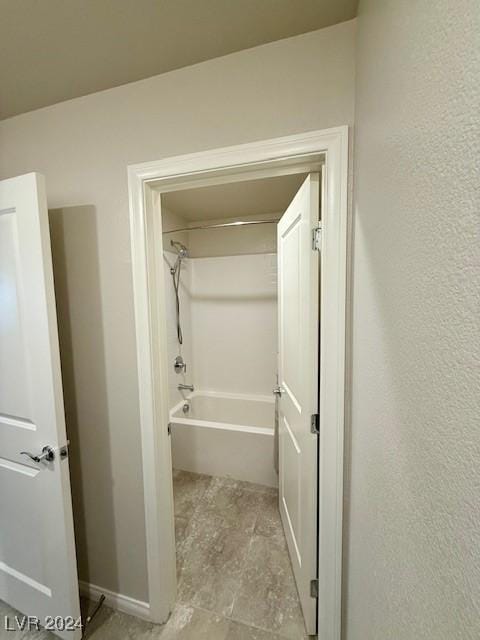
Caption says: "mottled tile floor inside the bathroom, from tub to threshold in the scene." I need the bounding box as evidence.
[173,471,305,640]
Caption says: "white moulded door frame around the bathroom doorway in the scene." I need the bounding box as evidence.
[128,126,348,640]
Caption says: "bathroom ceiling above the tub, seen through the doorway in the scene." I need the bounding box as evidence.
[162,173,306,222]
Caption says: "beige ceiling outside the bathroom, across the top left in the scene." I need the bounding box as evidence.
[0,0,358,119]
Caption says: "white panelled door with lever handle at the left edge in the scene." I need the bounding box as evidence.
[0,173,81,640]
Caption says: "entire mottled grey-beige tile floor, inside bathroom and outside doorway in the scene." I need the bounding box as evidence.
[0,471,306,640]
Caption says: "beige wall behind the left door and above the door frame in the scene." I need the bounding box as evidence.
[0,22,355,599]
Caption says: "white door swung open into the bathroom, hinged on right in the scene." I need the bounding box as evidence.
[277,173,320,634]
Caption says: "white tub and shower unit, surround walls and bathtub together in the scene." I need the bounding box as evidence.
[169,250,277,486]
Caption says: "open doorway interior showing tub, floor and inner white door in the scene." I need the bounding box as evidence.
[165,166,322,637]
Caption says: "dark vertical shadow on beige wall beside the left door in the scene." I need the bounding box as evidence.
[49,205,118,585]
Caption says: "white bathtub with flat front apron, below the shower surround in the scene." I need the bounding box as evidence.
[170,391,277,487]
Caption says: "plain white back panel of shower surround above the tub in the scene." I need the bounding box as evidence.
[185,252,277,395]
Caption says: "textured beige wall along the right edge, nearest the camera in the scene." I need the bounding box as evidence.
[345,0,480,640]
